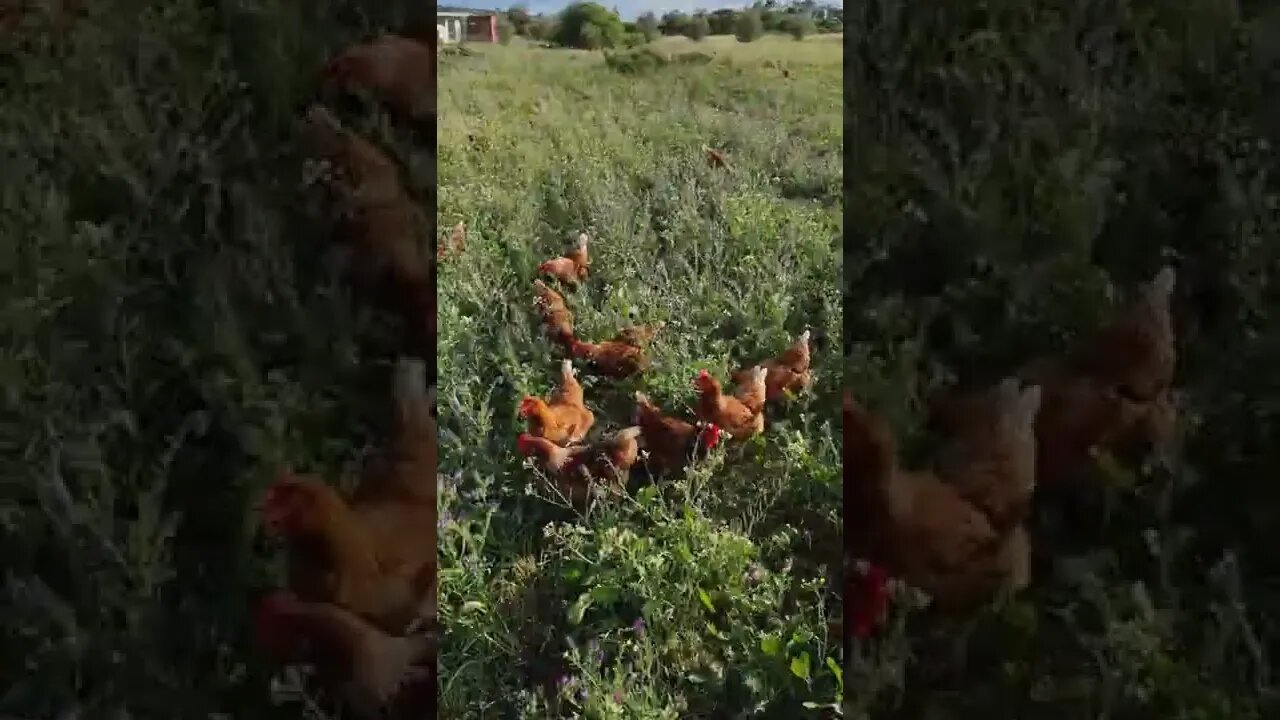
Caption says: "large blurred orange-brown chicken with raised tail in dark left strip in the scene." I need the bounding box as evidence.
[262,360,436,633]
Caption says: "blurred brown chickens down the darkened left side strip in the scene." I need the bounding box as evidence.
[248,29,438,719]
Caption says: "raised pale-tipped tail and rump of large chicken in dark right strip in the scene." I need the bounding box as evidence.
[934,378,1043,533]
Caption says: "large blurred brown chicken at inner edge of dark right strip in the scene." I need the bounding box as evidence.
[844,388,1038,612]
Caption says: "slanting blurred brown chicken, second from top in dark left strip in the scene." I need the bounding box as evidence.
[300,105,435,359]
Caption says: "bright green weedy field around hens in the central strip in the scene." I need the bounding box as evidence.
[438,32,842,719]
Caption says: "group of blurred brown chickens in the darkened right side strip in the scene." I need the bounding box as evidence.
[844,268,1178,635]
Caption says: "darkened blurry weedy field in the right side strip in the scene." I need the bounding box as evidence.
[845,0,1280,719]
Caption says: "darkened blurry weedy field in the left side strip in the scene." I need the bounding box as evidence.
[0,0,431,719]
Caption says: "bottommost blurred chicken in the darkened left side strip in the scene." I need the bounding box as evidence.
[255,591,435,720]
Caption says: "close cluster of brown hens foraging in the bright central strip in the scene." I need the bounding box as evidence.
[516,233,813,506]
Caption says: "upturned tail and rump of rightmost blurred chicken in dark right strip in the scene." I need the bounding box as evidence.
[1074,268,1178,402]
